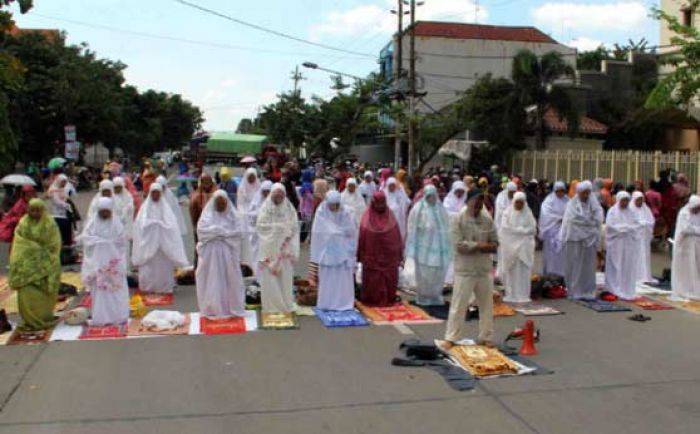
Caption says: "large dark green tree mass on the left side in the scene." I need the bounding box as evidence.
[5,29,203,161]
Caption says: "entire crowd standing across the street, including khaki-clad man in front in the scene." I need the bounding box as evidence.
[0,158,700,349]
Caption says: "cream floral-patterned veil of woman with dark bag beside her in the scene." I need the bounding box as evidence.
[255,182,299,262]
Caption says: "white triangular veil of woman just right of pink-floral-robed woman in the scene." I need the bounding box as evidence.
[132,182,188,267]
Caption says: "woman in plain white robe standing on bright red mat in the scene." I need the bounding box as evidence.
[195,190,245,318]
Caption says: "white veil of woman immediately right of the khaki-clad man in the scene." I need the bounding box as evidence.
[498,191,537,270]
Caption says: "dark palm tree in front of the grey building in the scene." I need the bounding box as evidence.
[511,50,579,149]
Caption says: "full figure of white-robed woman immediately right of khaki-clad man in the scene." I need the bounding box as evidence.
[498,191,537,303]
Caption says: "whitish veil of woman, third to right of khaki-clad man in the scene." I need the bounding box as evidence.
[559,181,604,247]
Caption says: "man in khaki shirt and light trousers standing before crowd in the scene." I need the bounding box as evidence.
[436,190,498,351]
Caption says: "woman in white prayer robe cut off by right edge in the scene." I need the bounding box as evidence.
[671,194,700,301]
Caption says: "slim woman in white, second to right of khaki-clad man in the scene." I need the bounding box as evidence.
[539,181,569,277]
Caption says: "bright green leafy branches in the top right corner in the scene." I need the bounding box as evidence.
[646,0,700,110]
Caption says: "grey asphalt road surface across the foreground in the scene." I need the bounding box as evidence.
[0,187,700,434]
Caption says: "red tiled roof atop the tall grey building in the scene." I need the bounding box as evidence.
[408,21,557,44]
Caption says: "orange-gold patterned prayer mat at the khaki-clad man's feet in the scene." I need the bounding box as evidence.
[449,345,521,378]
